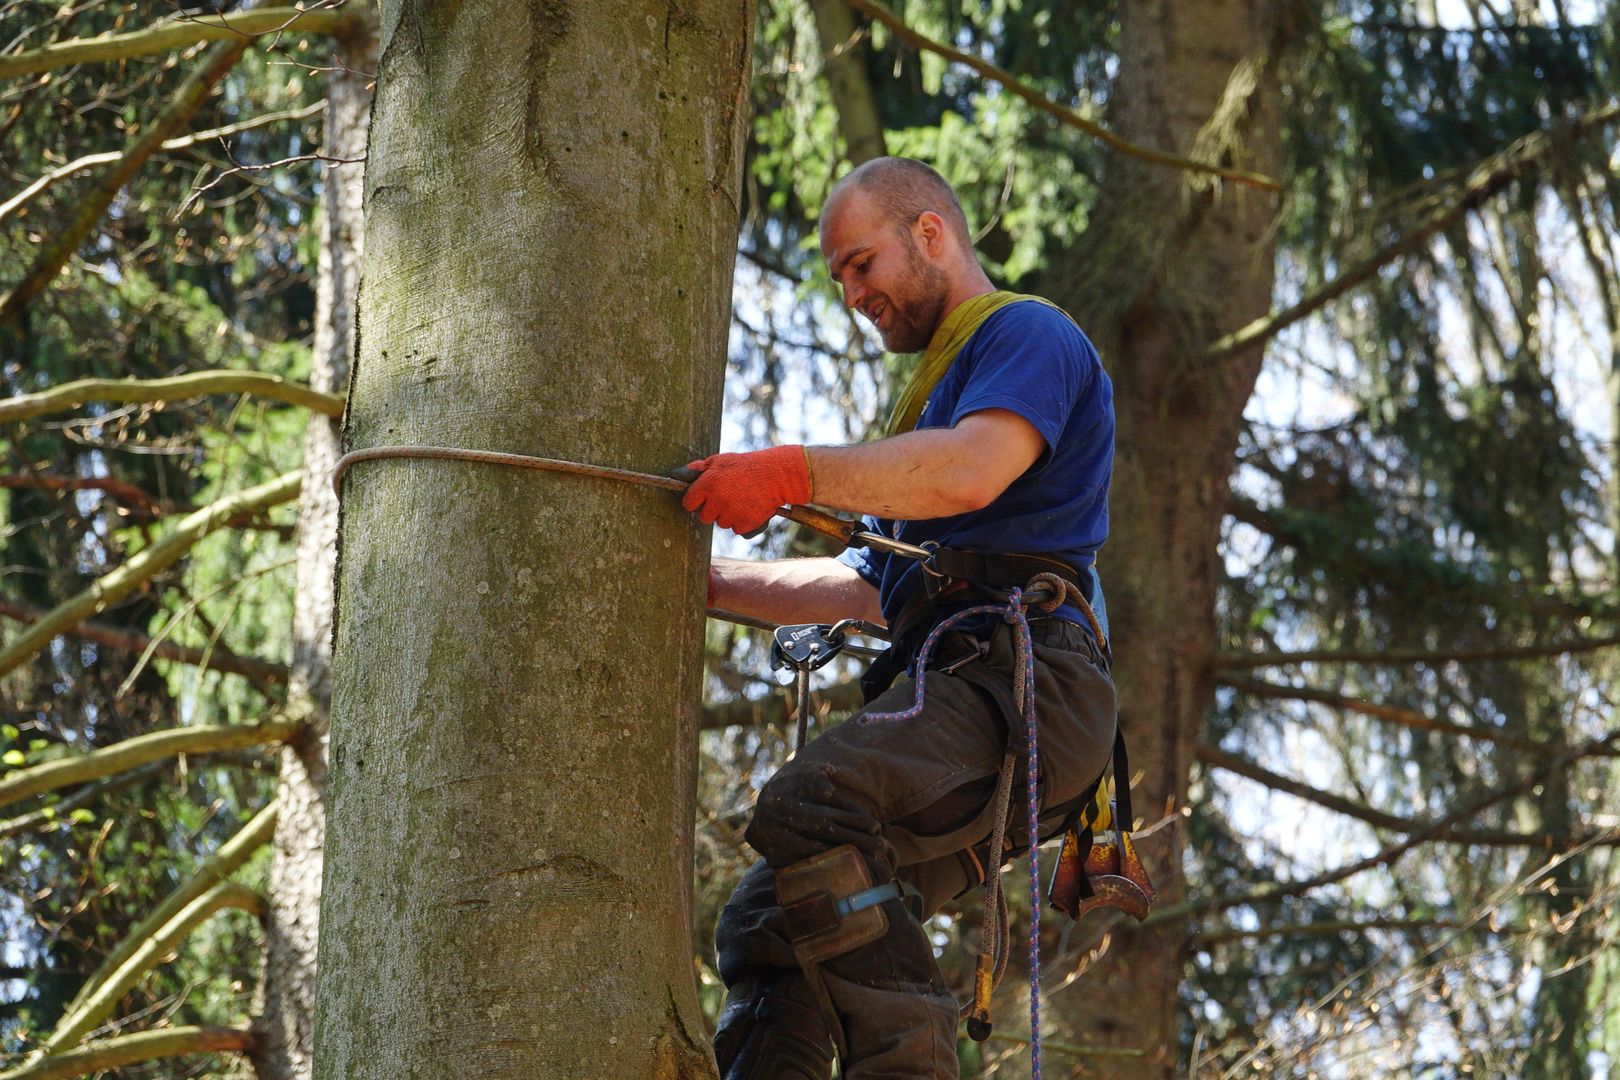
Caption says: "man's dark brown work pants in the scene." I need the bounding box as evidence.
[716,619,1116,1080]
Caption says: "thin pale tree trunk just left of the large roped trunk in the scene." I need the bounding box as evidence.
[253,3,377,1080]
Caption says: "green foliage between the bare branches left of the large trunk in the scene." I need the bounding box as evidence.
[0,3,327,1075]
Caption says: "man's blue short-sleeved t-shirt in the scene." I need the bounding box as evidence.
[839,301,1115,650]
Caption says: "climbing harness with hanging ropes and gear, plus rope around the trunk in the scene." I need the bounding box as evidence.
[332,447,1153,1080]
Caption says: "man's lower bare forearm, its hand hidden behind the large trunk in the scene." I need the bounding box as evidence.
[711,559,883,625]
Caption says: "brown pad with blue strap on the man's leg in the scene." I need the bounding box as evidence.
[776,844,901,1057]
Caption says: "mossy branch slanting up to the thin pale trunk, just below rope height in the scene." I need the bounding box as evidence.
[0,473,301,675]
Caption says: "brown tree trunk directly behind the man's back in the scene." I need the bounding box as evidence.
[1050,0,1281,1080]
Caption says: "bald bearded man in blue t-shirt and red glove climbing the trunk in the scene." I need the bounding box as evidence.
[685,157,1116,1080]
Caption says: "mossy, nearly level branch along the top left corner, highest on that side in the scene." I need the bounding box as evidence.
[0,6,356,79]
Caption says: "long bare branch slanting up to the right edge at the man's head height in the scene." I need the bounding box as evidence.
[1205,102,1620,361]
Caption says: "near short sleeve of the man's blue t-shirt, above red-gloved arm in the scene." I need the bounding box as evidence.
[951,301,1095,450]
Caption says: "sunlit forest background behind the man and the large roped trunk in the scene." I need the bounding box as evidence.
[0,0,1620,1080]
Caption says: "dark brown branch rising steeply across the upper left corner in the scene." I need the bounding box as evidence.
[0,34,253,327]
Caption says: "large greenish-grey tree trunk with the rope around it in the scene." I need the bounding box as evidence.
[316,0,753,1080]
